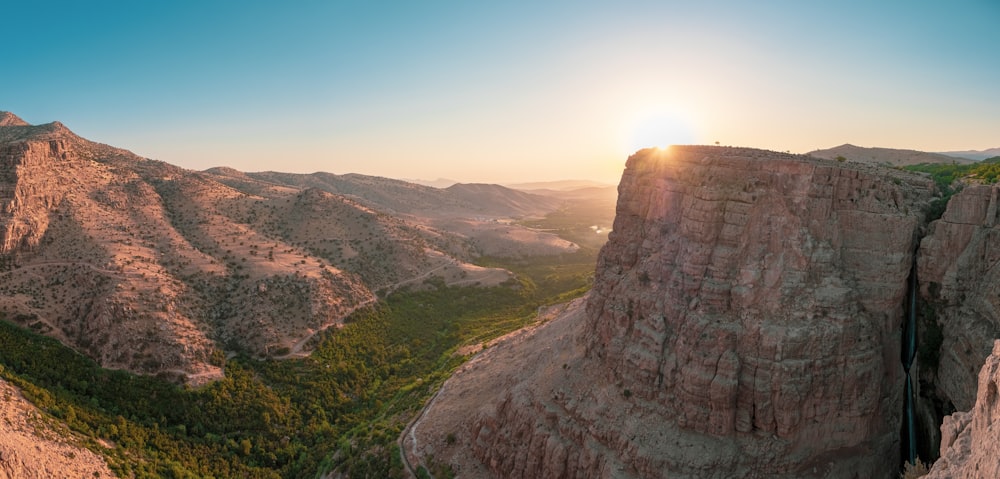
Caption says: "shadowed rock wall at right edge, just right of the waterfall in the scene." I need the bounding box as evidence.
[918,185,1000,411]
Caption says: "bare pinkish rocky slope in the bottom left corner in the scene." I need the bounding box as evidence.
[0,380,117,479]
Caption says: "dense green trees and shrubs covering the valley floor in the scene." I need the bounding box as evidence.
[0,215,596,478]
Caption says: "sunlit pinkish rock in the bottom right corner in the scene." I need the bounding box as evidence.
[926,341,1000,479]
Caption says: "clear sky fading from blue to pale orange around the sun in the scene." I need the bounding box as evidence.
[0,0,1000,184]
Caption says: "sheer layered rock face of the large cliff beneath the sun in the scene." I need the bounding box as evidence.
[588,149,930,450]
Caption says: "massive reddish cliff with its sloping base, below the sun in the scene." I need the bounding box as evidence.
[414,147,934,478]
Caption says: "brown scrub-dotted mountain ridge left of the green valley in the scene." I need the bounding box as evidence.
[0,112,576,382]
